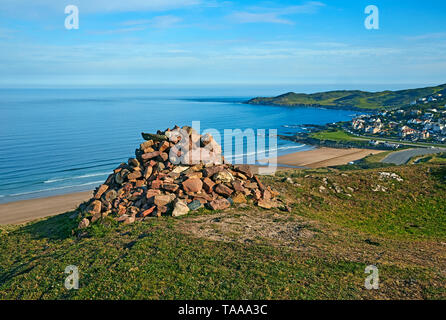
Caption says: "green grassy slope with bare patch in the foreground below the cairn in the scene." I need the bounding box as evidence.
[0,164,446,299]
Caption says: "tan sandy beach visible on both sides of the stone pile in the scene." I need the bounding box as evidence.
[0,148,382,225]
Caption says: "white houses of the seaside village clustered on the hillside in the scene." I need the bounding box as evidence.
[350,94,446,144]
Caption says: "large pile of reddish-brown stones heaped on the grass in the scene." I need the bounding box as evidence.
[79,127,278,229]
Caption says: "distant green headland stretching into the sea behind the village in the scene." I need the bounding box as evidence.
[247,84,446,110]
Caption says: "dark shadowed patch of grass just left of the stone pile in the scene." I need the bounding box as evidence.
[21,211,78,240]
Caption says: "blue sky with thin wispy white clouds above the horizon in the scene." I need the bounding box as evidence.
[0,0,446,87]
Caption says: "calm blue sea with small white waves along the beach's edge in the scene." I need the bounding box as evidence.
[0,88,354,202]
